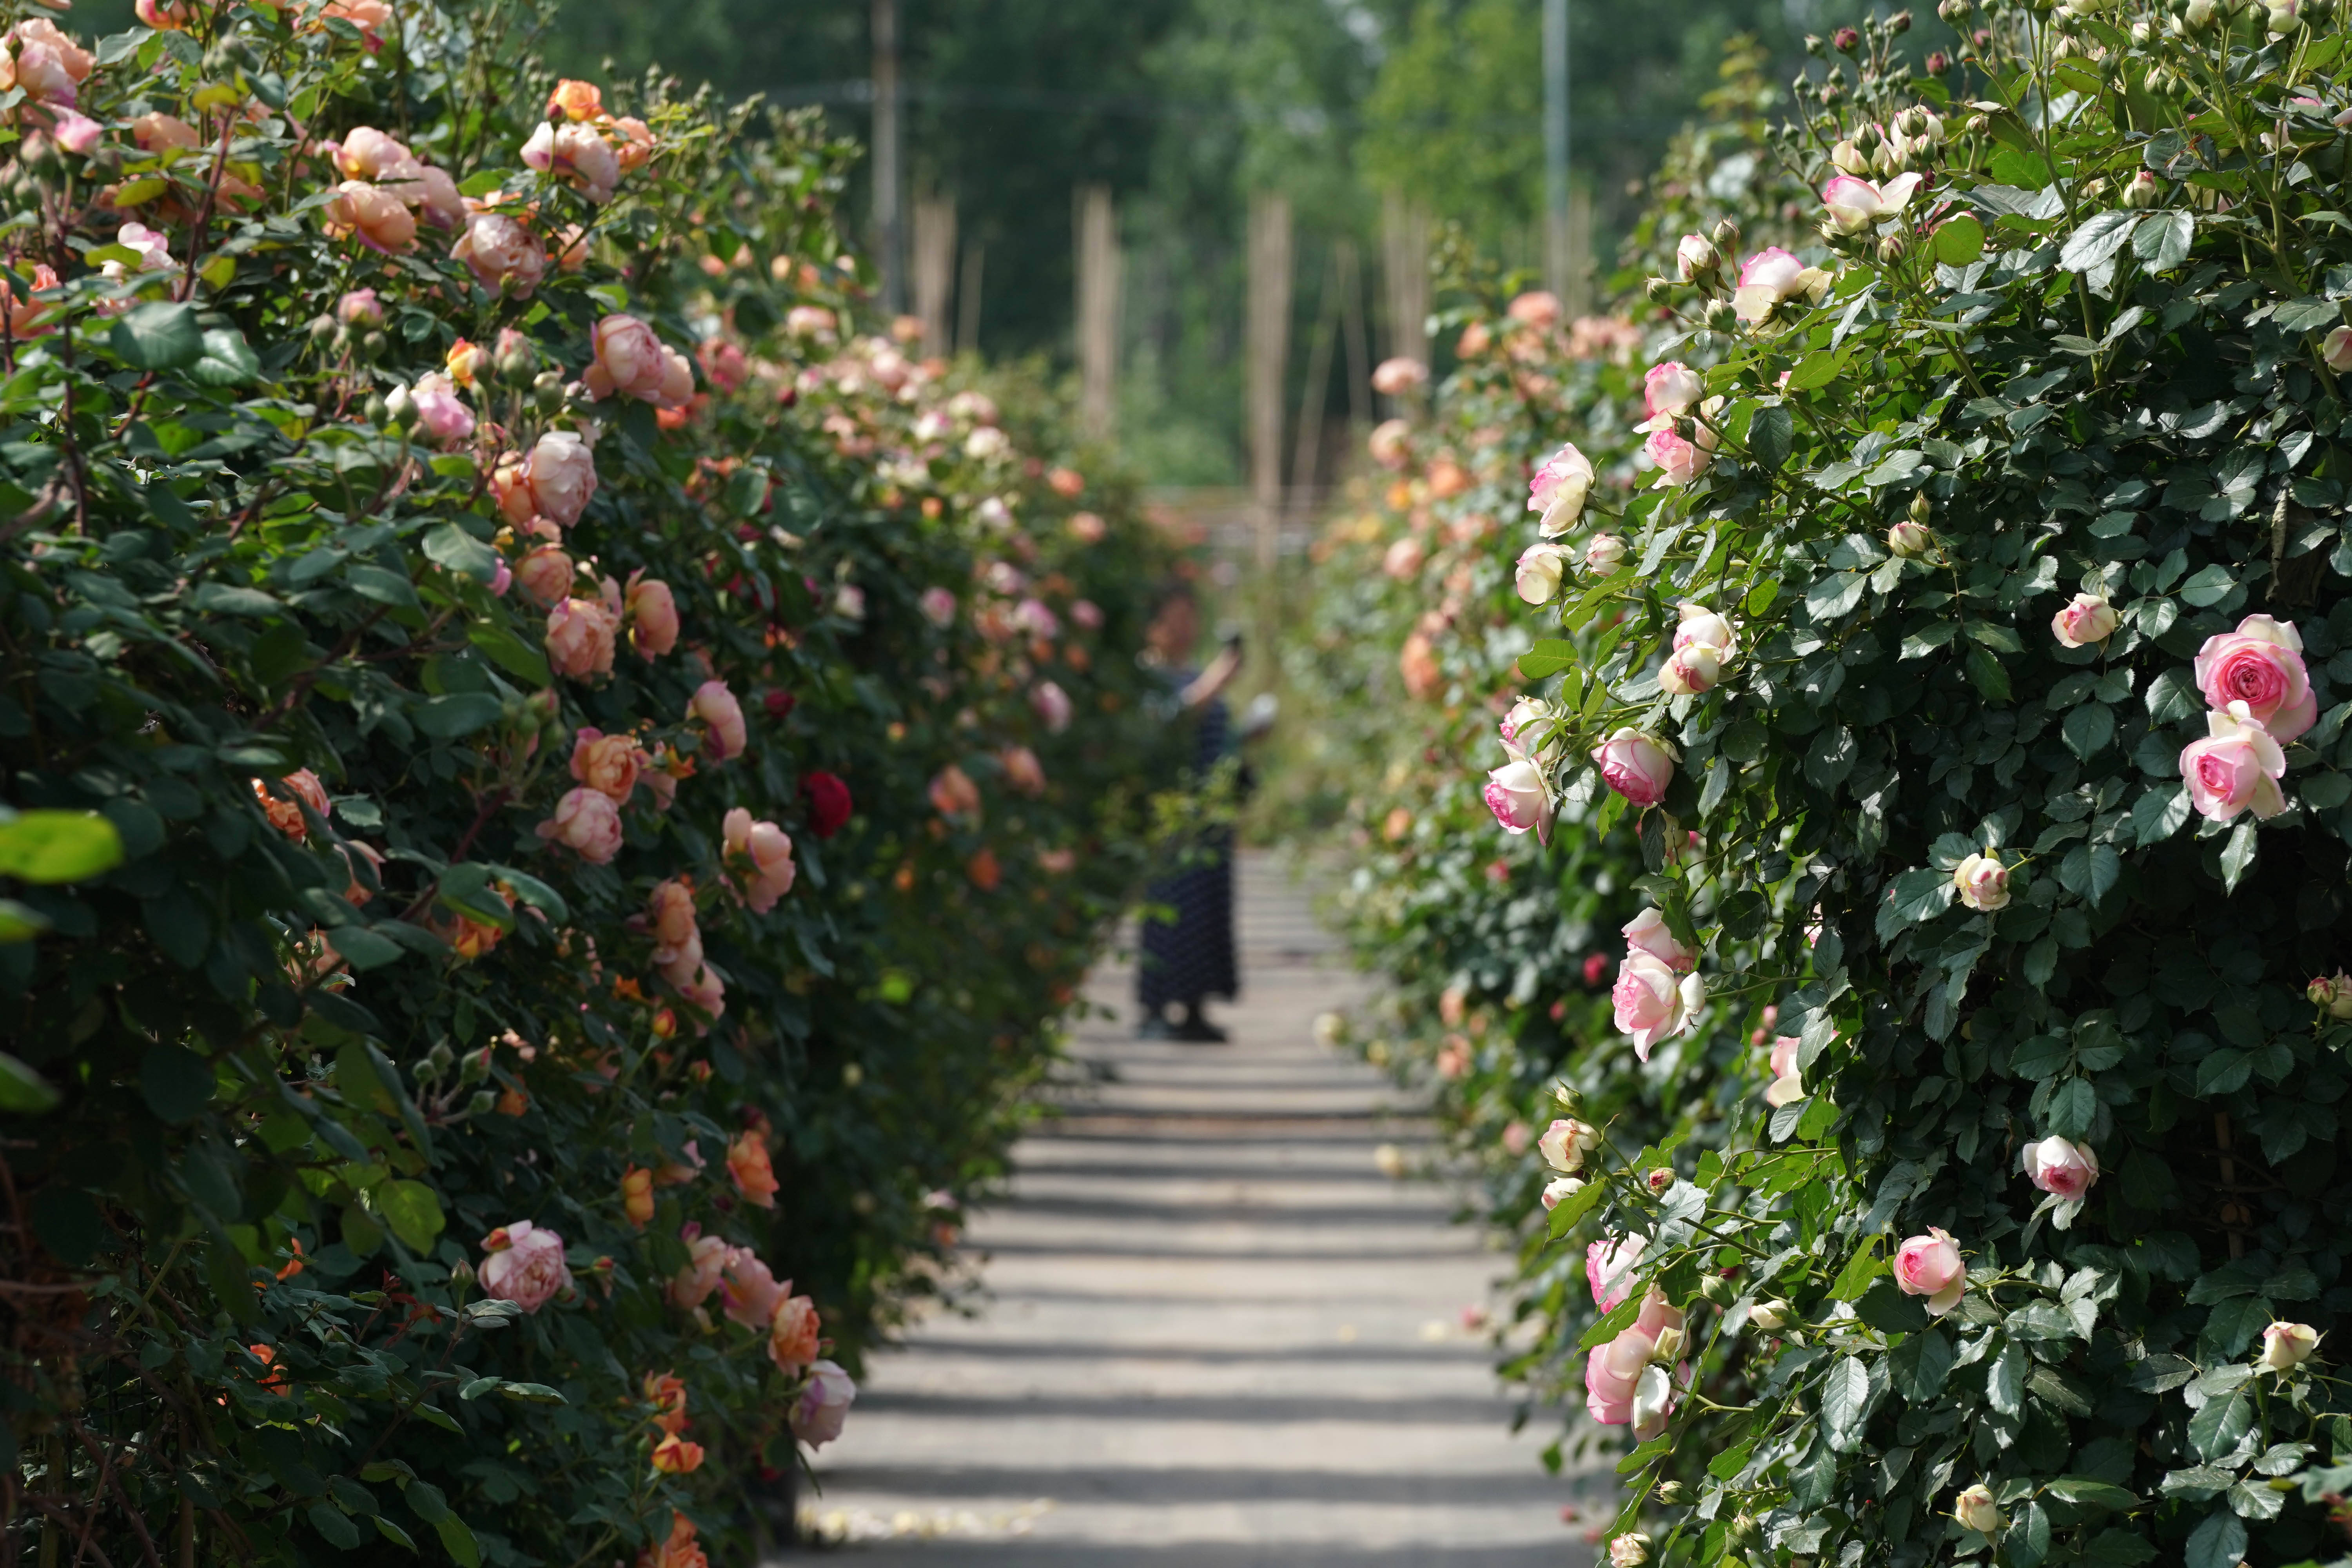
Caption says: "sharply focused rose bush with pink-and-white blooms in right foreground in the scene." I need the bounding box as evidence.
[1317,12,2352,1568]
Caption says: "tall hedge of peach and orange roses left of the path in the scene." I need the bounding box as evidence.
[0,0,1167,1568]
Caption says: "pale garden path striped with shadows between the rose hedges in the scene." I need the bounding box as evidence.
[804,856,1592,1568]
